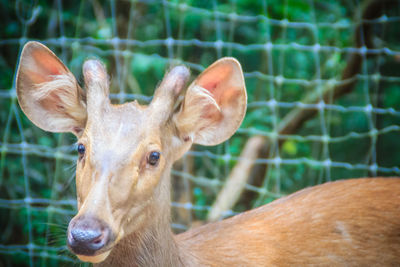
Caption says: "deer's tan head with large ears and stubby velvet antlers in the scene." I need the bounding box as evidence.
[16,42,246,262]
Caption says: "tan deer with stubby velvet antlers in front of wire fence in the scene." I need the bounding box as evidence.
[16,41,400,266]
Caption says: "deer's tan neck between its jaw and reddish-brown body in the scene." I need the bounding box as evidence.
[95,166,192,267]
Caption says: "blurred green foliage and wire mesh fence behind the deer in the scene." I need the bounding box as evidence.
[0,0,400,266]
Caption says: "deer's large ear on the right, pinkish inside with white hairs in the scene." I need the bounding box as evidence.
[174,58,247,145]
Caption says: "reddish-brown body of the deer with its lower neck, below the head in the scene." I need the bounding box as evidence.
[94,178,400,266]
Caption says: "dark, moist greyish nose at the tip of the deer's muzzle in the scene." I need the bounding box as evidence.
[67,218,111,256]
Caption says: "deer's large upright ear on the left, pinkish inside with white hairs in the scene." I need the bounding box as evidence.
[16,42,87,137]
